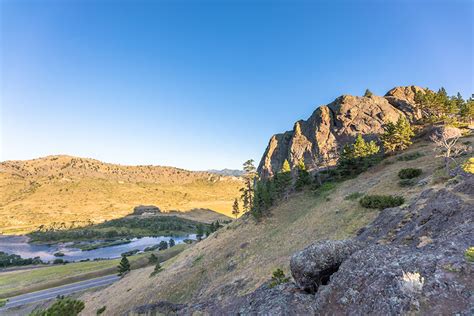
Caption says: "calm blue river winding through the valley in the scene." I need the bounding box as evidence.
[0,235,196,261]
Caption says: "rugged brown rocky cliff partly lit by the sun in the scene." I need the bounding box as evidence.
[258,86,424,177]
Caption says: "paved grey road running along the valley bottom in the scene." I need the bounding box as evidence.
[0,275,120,312]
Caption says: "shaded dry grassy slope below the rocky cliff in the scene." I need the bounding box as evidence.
[83,137,473,315]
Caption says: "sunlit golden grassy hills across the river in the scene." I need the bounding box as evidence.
[0,156,241,234]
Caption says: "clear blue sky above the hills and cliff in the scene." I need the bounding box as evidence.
[0,0,474,170]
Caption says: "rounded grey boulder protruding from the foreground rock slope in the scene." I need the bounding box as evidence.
[290,240,360,293]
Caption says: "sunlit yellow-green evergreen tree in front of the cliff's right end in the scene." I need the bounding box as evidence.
[380,115,415,153]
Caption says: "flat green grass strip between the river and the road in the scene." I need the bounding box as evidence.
[0,244,189,298]
